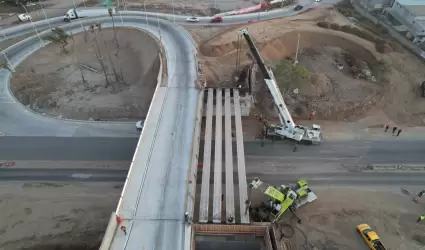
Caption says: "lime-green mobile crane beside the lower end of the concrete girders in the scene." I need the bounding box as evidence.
[250,178,317,223]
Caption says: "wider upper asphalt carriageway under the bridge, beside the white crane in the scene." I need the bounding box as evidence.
[0,137,425,164]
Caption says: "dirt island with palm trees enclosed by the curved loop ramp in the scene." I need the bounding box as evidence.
[11,27,159,120]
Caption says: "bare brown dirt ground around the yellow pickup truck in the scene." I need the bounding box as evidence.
[262,187,425,250]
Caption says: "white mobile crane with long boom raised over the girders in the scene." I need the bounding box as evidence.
[239,29,322,144]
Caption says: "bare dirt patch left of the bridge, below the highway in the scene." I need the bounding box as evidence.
[0,182,122,250]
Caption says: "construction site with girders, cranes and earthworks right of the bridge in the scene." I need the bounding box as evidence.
[187,6,424,250]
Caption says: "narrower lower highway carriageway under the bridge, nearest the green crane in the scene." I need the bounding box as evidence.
[0,168,425,187]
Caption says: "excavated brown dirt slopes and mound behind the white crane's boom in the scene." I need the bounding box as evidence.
[190,9,425,126]
